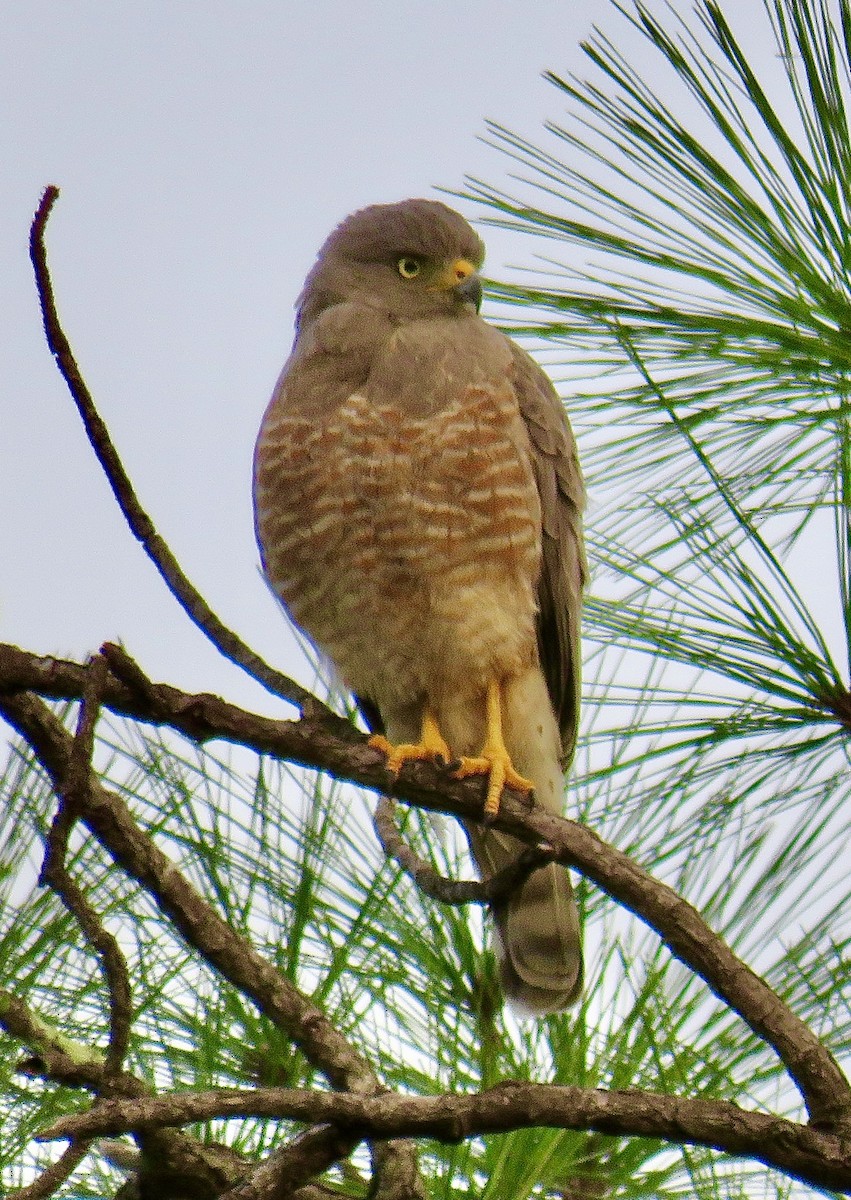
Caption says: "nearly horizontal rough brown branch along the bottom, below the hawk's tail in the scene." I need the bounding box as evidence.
[42,1084,851,1192]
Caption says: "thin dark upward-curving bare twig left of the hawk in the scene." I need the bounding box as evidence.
[30,186,325,712]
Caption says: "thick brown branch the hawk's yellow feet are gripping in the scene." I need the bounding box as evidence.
[0,644,851,1128]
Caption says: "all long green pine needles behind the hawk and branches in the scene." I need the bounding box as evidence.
[0,0,851,1200]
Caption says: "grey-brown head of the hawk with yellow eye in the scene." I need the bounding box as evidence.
[298,200,485,329]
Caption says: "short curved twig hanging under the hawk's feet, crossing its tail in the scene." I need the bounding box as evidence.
[372,796,552,906]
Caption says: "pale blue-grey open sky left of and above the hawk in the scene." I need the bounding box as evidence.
[0,0,625,715]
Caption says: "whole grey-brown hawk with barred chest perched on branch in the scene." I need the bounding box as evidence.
[254,199,585,1013]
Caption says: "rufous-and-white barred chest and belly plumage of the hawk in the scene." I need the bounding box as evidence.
[257,350,541,707]
